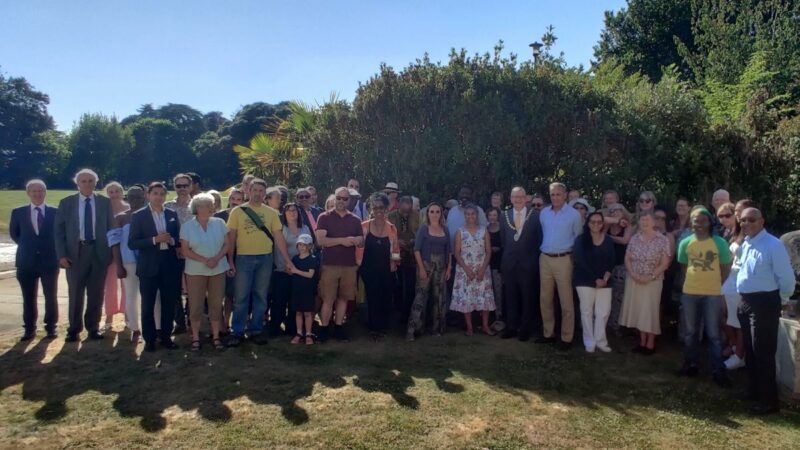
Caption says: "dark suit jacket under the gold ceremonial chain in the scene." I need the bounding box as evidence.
[500,208,542,272]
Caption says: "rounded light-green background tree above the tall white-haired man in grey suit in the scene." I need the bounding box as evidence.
[67,114,133,183]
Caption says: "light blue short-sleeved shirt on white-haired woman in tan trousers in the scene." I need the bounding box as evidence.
[181,217,228,276]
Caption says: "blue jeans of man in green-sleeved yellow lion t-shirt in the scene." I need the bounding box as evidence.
[681,294,725,373]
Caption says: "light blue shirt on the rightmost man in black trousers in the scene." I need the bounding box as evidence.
[736,230,795,300]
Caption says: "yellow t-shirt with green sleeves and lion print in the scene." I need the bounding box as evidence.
[677,234,731,295]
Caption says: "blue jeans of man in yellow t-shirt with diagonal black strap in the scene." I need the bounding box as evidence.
[232,253,272,336]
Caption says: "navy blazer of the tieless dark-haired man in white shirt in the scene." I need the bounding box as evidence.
[128,206,181,277]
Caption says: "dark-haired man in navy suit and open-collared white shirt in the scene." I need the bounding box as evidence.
[128,182,181,352]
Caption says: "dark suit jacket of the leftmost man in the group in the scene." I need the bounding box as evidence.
[8,205,58,271]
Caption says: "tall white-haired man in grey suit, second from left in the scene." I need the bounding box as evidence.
[55,169,113,342]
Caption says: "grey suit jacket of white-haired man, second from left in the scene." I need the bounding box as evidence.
[55,194,114,263]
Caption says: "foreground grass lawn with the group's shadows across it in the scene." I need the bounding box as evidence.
[0,323,800,449]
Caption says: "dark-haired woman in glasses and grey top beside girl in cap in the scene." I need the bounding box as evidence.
[269,203,313,336]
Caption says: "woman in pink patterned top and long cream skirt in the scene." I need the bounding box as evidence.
[621,209,672,355]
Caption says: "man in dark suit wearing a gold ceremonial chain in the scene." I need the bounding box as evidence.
[500,186,542,341]
